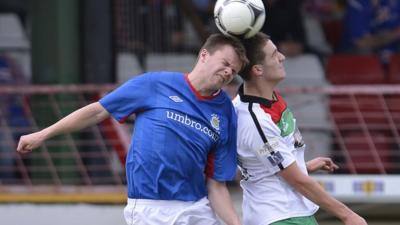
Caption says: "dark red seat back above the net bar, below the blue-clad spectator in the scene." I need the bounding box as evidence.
[326,54,385,84]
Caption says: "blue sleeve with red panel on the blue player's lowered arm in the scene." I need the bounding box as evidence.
[206,107,237,182]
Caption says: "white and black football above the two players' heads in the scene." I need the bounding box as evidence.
[214,0,265,38]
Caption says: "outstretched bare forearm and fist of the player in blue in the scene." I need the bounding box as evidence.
[17,102,109,153]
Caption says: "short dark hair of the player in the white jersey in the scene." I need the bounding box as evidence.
[239,32,270,80]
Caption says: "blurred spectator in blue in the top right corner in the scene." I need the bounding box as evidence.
[342,0,400,63]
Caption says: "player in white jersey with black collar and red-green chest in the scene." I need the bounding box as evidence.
[234,33,367,225]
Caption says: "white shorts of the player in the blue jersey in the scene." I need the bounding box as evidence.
[124,197,220,225]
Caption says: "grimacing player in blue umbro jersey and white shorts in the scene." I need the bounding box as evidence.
[17,34,247,225]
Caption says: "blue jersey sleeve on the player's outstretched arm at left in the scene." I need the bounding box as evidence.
[99,73,156,122]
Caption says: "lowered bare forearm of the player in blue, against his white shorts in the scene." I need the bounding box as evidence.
[207,178,241,225]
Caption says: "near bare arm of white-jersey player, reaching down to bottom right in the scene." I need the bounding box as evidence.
[279,163,367,225]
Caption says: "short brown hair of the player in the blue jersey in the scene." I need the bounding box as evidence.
[201,33,249,70]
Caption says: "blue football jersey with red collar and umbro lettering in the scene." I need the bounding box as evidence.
[100,72,237,201]
